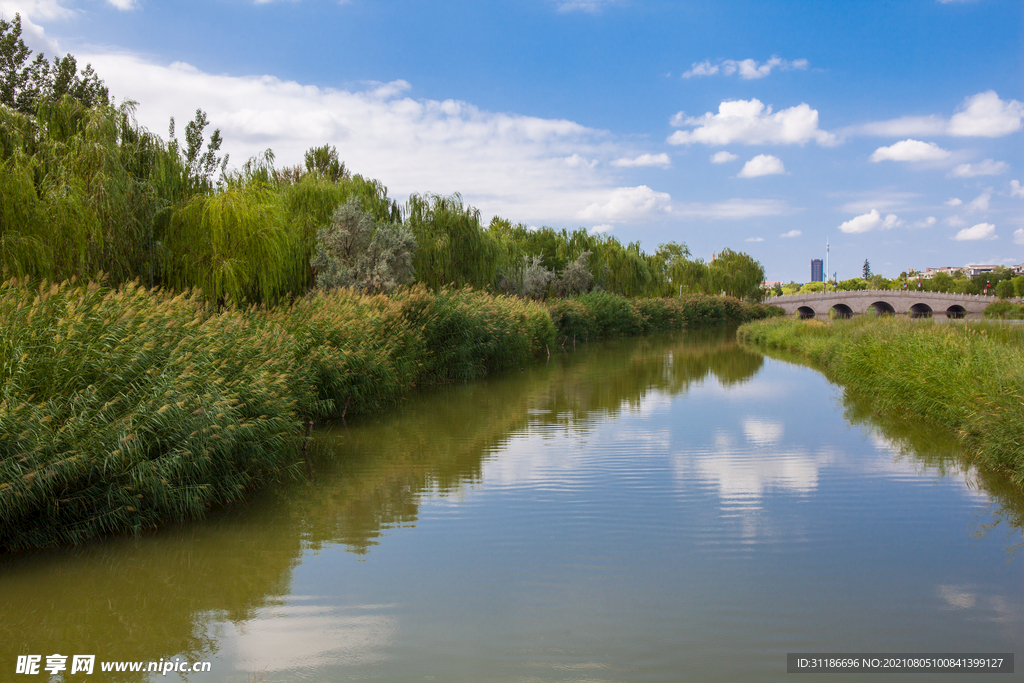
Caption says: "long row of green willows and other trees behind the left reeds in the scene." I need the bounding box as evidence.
[0,14,764,303]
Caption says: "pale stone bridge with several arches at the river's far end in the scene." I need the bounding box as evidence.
[765,290,995,319]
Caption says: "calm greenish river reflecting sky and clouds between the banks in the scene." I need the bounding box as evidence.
[0,330,1024,683]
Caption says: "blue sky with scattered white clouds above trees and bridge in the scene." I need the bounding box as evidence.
[0,0,1024,282]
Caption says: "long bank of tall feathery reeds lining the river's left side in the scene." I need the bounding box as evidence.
[0,281,768,551]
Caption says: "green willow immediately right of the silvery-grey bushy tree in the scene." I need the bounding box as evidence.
[406,195,501,289]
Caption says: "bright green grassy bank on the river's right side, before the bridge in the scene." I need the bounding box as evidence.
[738,317,1024,486]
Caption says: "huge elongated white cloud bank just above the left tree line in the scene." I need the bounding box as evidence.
[77,52,655,224]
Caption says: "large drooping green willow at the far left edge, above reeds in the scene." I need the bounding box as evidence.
[0,96,159,281]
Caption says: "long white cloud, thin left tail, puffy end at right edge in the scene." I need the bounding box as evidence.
[842,90,1024,137]
